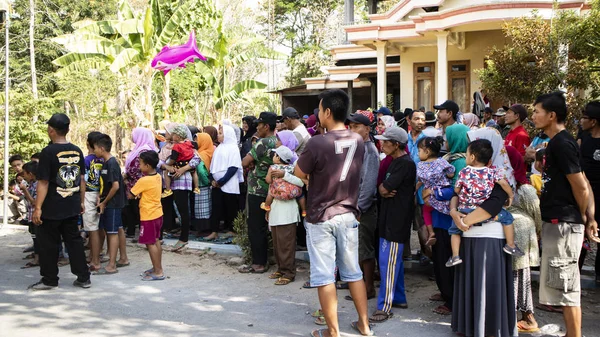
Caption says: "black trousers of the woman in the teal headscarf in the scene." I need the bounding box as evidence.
[431,228,456,310]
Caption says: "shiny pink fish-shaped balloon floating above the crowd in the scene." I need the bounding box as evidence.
[151,31,206,75]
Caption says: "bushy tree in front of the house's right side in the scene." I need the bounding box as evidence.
[479,5,600,130]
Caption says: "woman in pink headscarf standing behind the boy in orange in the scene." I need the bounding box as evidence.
[123,128,158,244]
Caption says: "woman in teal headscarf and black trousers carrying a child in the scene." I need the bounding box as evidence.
[423,124,469,315]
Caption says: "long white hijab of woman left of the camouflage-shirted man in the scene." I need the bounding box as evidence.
[210,125,244,194]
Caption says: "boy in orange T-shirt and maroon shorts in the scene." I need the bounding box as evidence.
[131,151,165,281]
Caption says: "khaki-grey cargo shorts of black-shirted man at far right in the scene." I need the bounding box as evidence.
[540,222,585,307]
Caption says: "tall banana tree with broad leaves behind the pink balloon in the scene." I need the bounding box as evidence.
[53,0,214,125]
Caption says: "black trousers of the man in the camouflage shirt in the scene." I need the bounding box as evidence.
[247,194,269,266]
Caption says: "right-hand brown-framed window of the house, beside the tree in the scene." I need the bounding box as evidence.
[448,61,471,112]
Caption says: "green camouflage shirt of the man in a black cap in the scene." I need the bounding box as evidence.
[248,136,277,197]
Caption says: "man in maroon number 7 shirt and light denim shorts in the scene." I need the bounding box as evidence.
[294,89,371,337]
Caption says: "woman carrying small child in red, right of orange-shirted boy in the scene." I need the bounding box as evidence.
[158,123,200,251]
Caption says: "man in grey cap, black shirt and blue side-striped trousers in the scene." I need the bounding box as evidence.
[369,126,417,323]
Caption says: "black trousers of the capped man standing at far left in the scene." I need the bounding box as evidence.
[36,216,90,286]
